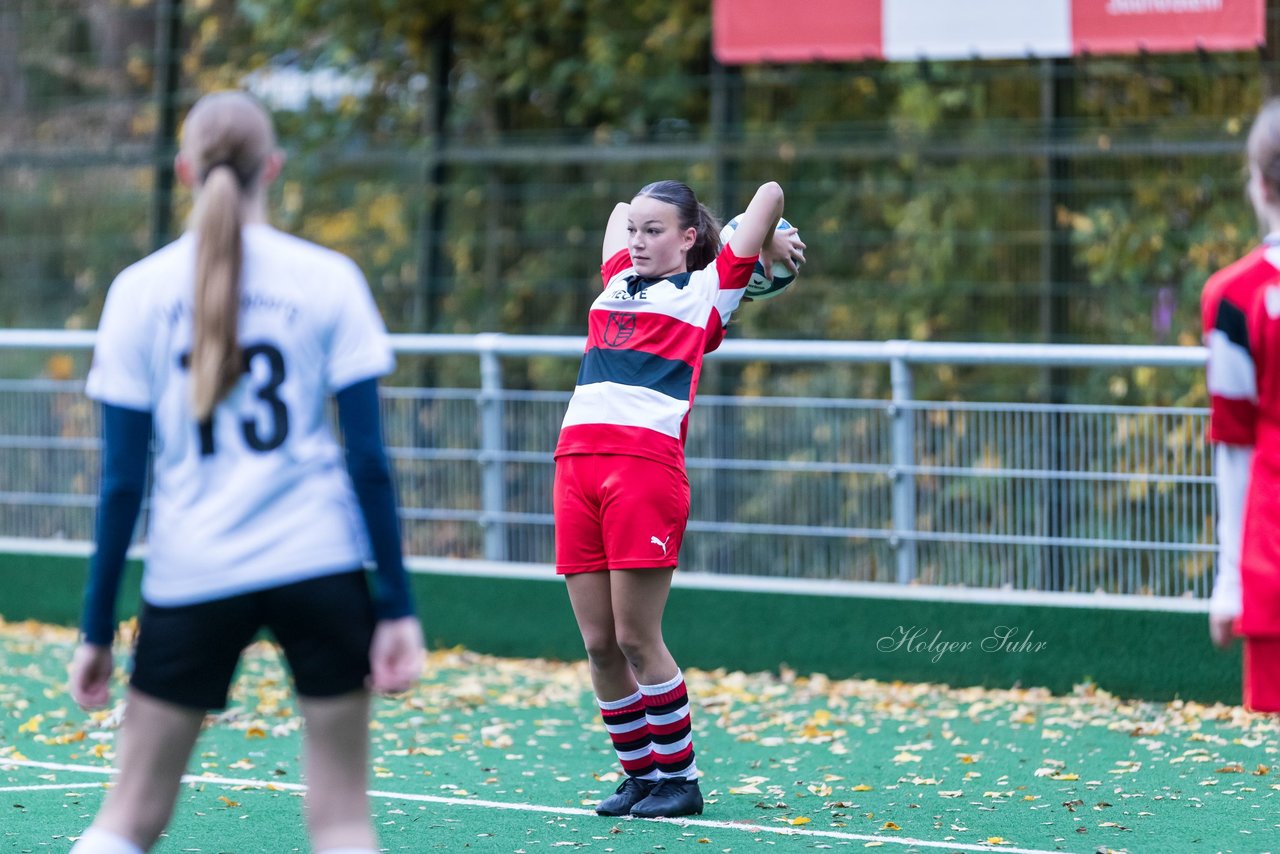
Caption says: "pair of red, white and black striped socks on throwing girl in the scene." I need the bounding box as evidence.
[596,671,698,780]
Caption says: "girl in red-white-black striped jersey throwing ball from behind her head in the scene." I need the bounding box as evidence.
[554,181,805,817]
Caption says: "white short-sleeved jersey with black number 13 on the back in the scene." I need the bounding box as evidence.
[86,225,394,606]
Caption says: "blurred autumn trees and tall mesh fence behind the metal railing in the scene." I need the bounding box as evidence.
[0,0,1280,403]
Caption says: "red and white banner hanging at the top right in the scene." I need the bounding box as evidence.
[712,0,1266,64]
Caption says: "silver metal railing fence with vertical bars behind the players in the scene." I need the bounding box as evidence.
[0,330,1215,597]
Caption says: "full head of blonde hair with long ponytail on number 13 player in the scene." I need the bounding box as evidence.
[182,92,275,421]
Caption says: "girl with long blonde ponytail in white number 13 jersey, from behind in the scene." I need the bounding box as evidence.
[69,92,422,854]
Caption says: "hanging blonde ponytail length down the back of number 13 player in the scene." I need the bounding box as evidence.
[191,164,244,421]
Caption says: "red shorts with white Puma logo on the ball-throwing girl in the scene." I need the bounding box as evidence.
[554,453,689,575]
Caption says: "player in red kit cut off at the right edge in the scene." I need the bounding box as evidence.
[1201,100,1280,712]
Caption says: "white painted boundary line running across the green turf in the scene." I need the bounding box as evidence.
[0,758,1062,854]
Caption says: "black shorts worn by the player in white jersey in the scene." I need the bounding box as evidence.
[129,570,375,711]
